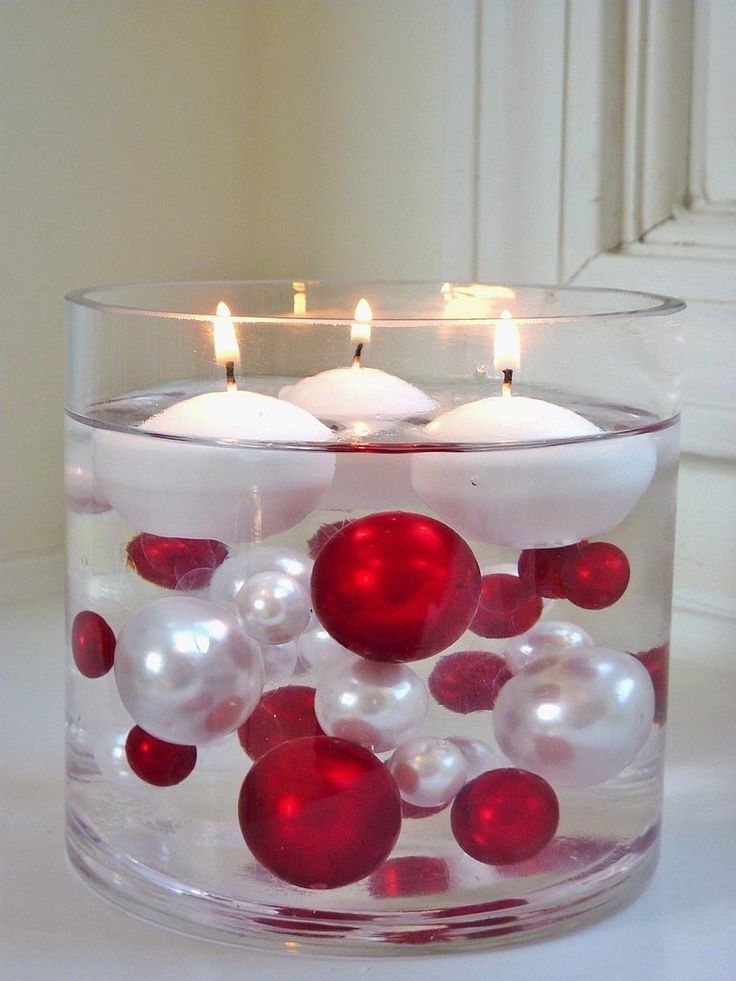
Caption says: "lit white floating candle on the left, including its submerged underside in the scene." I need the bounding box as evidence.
[93,304,335,542]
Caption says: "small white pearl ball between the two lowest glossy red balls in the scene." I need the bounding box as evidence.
[388,736,467,807]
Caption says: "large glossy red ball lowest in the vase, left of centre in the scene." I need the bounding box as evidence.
[238,736,401,889]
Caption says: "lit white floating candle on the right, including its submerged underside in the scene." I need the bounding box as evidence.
[412,315,656,548]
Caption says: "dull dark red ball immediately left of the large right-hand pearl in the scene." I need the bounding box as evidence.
[428,651,513,715]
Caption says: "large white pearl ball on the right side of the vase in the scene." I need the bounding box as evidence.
[493,647,654,787]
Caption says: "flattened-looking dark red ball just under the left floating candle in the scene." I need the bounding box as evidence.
[126,532,228,590]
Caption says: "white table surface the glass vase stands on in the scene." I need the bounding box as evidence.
[0,597,736,981]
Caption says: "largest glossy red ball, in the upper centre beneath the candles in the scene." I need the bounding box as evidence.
[312,511,480,661]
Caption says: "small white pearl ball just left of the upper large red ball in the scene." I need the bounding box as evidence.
[235,572,311,645]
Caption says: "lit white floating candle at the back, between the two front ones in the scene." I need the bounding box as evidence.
[279,300,437,427]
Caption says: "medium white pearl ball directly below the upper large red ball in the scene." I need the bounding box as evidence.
[314,658,429,753]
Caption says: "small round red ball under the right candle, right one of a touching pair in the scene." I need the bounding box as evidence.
[560,542,631,610]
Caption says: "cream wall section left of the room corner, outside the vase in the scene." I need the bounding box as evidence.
[0,0,256,561]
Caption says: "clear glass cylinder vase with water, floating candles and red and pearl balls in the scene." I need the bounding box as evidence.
[66,282,683,954]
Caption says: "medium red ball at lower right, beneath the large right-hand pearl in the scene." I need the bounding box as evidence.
[450,767,560,865]
